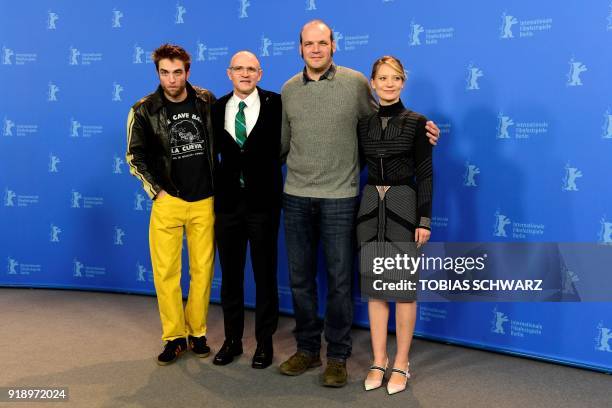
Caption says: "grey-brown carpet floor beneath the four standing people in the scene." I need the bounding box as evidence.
[0,288,612,408]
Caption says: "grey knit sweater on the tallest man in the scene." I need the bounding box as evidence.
[281,66,377,198]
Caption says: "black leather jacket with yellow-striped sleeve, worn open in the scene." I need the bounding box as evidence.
[126,83,215,199]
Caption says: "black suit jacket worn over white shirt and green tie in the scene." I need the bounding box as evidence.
[212,87,283,213]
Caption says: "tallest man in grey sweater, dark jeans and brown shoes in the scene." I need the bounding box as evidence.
[280,20,439,387]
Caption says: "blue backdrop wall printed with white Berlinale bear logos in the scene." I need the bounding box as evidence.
[0,0,612,371]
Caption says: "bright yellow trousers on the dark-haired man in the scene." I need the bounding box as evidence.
[149,194,215,341]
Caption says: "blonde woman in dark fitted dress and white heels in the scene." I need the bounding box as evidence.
[357,56,433,394]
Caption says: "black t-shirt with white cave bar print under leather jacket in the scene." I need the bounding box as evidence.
[164,92,213,201]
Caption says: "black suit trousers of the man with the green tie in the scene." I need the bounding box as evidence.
[215,200,280,343]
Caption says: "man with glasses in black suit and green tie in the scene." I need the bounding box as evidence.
[212,51,282,368]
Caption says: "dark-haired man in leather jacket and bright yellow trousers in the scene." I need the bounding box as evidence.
[126,44,215,365]
